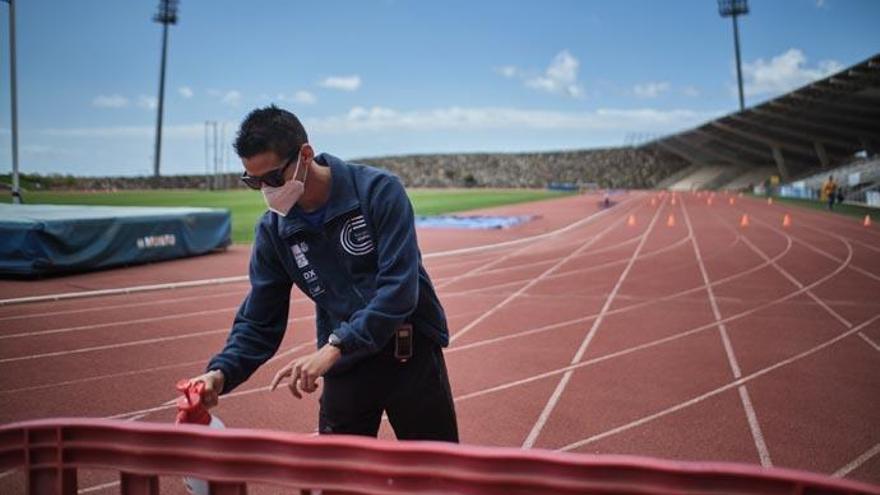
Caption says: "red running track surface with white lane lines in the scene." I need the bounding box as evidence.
[0,194,880,493]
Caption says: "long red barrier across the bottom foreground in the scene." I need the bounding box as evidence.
[0,418,880,495]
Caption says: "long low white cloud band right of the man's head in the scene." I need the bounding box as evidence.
[305,106,720,134]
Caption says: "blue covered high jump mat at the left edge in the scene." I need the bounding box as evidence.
[0,204,232,277]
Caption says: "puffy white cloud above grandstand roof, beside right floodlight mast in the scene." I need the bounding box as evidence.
[743,48,844,96]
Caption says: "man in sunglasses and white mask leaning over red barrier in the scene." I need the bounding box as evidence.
[187,106,458,442]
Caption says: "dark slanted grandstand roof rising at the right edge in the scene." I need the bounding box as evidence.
[641,54,880,180]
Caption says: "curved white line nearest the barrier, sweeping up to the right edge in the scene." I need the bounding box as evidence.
[558,314,880,451]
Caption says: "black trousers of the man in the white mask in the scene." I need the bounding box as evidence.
[318,332,458,442]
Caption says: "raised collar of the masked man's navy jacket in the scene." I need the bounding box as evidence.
[270,153,360,239]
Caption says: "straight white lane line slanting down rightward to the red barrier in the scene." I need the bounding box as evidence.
[681,197,773,467]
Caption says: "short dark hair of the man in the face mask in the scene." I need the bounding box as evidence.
[233,105,309,158]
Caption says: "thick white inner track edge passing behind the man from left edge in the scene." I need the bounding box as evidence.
[0,197,636,306]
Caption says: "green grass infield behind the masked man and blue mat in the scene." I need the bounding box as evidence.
[0,189,565,243]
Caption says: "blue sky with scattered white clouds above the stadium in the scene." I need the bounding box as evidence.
[0,0,880,176]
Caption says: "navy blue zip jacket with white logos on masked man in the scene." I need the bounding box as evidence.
[207,154,449,393]
